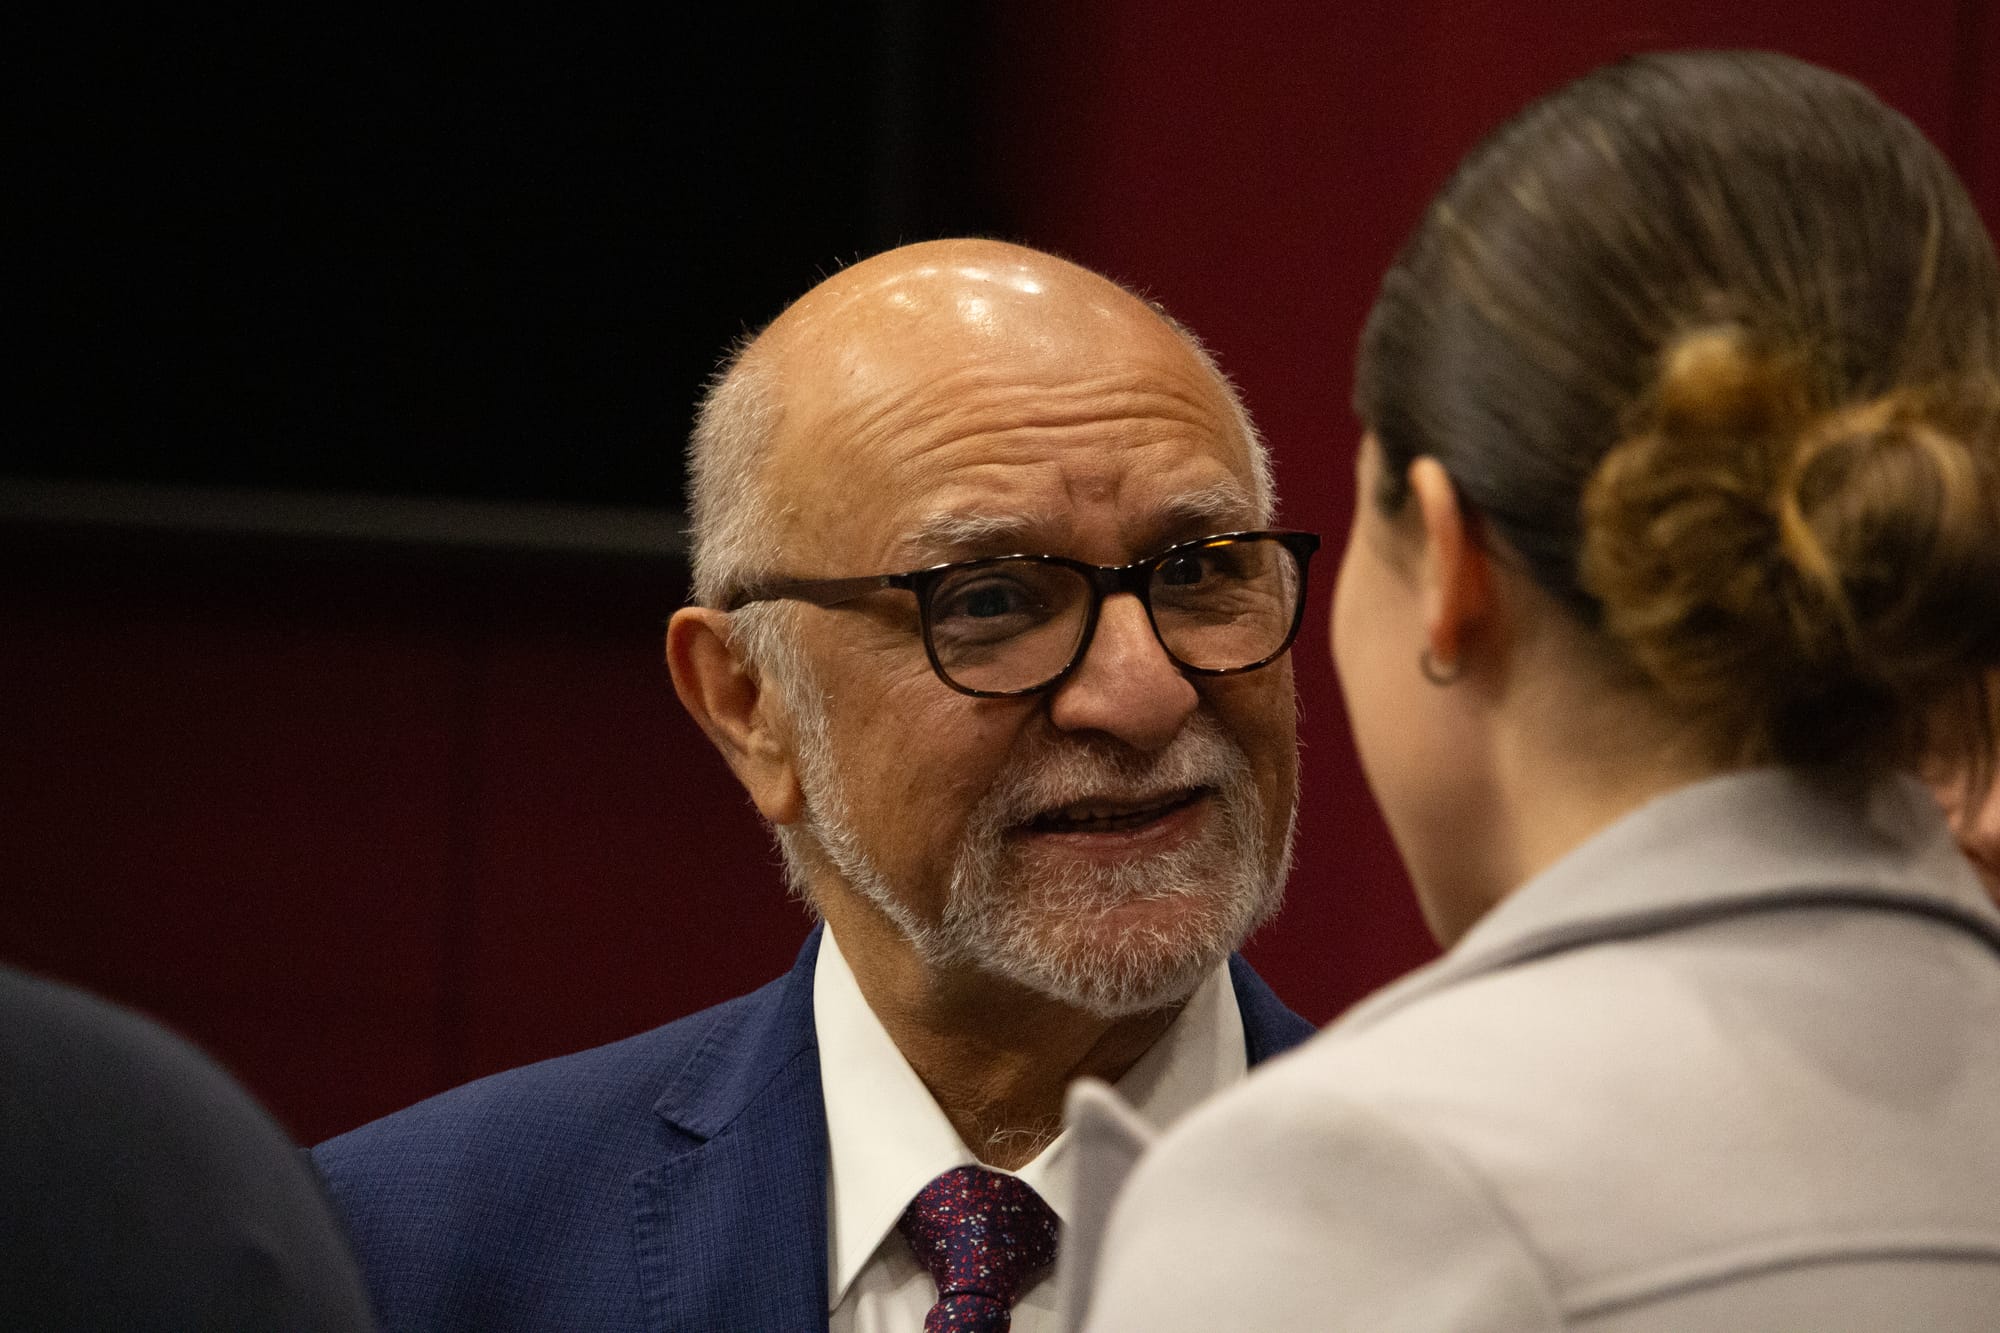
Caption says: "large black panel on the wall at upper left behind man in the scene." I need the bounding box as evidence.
[19,0,1008,506]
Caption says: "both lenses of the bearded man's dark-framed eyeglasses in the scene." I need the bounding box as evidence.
[928,538,1300,693]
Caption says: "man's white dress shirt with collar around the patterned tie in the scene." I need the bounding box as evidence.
[812,929,1248,1333]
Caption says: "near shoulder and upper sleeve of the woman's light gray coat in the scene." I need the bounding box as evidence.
[1088,1059,1568,1333]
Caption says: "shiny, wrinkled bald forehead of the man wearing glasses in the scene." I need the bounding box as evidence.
[766,250,1262,558]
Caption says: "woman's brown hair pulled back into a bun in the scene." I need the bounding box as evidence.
[1356,52,2000,781]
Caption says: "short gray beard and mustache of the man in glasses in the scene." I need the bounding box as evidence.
[780,691,1298,1019]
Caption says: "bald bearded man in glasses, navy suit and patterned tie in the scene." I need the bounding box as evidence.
[318,240,1316,1333]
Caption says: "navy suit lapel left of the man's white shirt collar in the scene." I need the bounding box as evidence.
[632,931,826,1333]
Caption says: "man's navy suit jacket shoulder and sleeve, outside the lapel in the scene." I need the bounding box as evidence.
[312,971,812,1331]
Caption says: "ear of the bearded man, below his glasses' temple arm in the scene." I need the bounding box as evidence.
[666,606,804,825]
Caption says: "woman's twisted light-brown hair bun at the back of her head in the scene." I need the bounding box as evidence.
[1580,326,2000,769]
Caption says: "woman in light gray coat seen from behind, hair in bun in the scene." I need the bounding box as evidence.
[1090,54,2000,1333]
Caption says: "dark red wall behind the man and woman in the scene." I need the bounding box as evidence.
[0,0,2000,1141]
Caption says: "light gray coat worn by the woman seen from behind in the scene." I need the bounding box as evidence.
[1088,771,2000,1333]
